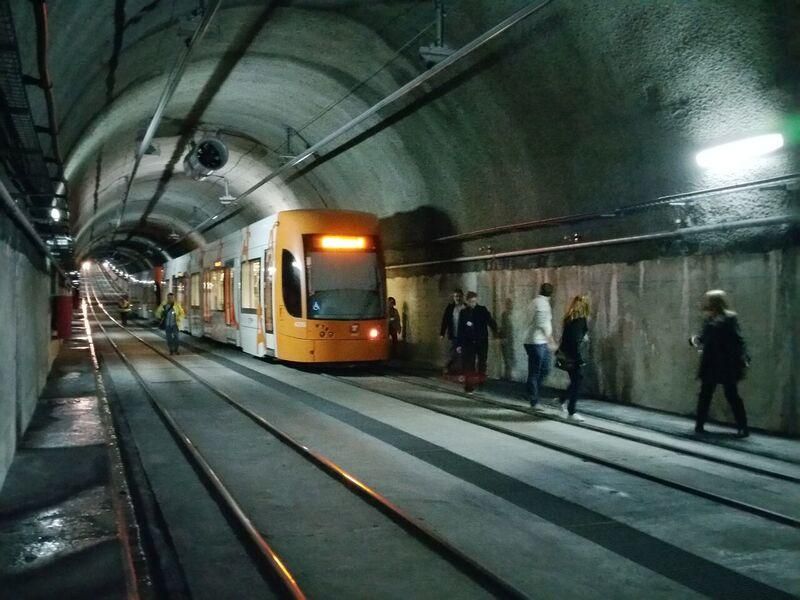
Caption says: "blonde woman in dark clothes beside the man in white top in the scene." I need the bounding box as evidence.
[556,296,589,421]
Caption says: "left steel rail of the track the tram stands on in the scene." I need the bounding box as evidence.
[324,375,800,529]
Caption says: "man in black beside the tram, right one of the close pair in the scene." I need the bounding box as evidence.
[456,292,497,393]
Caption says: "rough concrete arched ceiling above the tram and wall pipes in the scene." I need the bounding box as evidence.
[12,0,800,266]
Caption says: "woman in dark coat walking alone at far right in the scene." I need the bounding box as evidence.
[689,290,750,438]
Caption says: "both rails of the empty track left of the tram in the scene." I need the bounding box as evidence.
[90,289,527,598]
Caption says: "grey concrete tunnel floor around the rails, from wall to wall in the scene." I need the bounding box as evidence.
[0,306,800,598]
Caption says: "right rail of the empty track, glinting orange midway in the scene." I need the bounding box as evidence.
[89,294,529,600]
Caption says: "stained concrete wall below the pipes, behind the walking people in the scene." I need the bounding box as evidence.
[388,248,800,434]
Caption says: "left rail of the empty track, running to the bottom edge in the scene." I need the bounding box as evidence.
[87,286,306,600]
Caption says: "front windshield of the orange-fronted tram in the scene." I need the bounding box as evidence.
[306,250,385,321]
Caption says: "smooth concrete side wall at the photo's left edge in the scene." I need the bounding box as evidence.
[0,215,52,487]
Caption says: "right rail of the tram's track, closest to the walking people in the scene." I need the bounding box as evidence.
[382,373,800,483]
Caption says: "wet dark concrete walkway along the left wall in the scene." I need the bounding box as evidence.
[0,318,126,600]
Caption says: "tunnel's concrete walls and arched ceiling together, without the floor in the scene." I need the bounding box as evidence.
[0,0,800,596]
